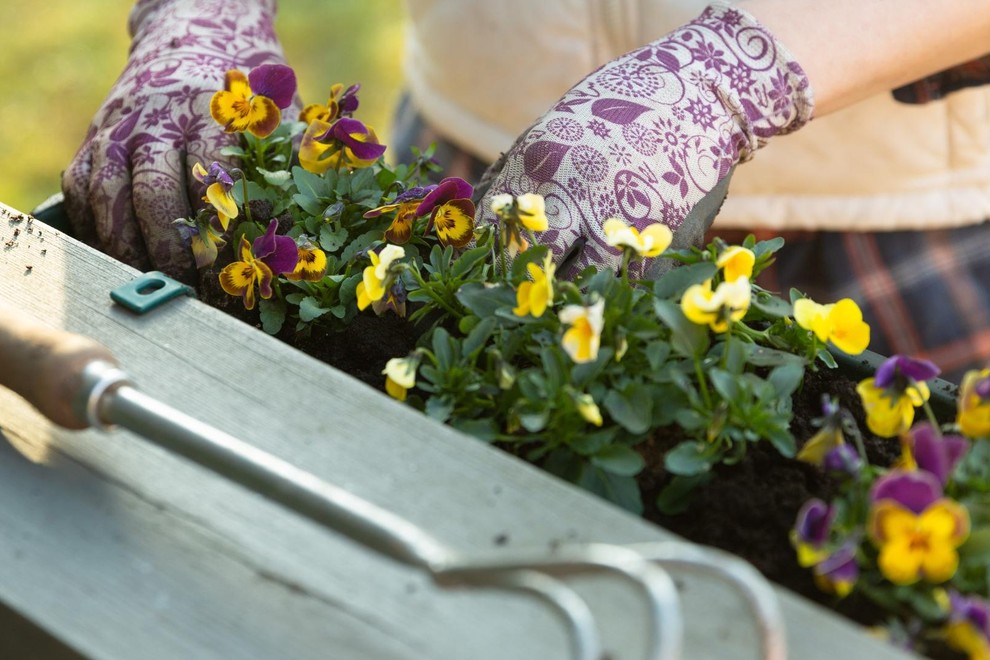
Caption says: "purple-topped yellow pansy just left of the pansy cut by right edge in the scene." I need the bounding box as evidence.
[856,355,939,438]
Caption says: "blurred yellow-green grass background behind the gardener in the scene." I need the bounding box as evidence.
[0,0,404,211]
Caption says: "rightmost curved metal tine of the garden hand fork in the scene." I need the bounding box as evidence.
[627,541,787,660]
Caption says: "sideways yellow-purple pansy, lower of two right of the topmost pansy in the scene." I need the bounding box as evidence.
[299,117,386,174]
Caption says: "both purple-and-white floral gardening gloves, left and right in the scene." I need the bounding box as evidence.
[63,0,813,279]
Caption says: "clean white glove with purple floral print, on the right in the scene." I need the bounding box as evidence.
[479,2,813,276]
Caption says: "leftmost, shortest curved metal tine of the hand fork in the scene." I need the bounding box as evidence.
[471,569,603,660]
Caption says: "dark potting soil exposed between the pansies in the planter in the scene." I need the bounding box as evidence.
[200,270,957,658]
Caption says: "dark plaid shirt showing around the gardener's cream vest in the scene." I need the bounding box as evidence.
[392,65,990,383]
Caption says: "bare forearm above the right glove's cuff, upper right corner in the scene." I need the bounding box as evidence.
[739,0,990,116]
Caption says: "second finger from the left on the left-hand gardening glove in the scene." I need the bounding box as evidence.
[85,126,151,270]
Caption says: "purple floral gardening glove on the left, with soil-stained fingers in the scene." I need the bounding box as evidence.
[62,0,288,279]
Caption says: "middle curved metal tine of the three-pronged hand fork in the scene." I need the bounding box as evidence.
[432,543,684,660]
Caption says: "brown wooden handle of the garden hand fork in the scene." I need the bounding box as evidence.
[0,302,117,429]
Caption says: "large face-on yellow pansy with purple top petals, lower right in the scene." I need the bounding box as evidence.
[867,470,970,585]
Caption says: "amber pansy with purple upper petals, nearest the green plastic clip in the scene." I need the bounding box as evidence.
[220,219,299,309]
